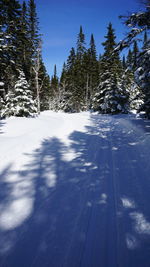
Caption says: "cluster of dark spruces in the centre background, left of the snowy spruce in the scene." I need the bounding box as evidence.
[60,27,99,112]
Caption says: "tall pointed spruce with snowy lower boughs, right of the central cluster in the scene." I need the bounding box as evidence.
[93,23,128,114]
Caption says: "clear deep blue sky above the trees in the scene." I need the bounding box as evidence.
[28,0,141,76]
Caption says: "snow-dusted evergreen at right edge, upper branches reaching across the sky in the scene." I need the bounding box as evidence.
[116,0,150,118]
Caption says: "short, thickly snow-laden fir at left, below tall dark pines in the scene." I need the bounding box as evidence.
[2,71,37,117]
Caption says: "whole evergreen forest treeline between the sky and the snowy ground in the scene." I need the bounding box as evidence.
[0,0,150,118]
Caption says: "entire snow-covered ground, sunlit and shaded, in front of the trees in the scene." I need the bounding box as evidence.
[0,112,150,267]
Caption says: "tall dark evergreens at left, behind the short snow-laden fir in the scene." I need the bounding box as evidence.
[0,0,50,117]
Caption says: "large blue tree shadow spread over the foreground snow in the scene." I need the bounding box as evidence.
[0,116,150,267]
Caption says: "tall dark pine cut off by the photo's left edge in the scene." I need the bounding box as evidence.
[0,0,21,94]
